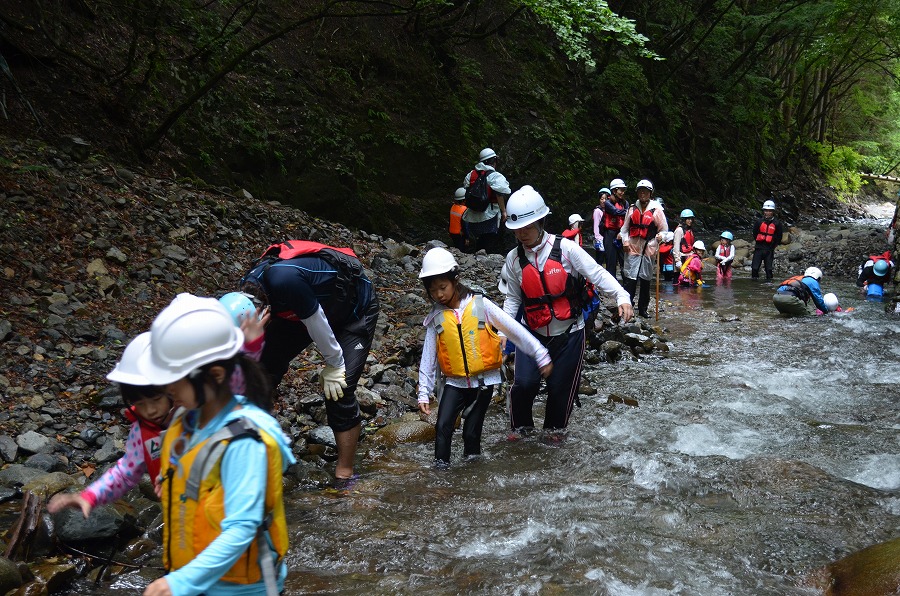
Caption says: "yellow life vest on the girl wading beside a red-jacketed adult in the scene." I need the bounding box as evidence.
[432,294,503,377]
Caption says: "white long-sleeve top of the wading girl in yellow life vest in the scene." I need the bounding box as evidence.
[418,294,550,404]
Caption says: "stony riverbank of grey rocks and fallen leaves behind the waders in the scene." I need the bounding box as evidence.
[0,139,885,594]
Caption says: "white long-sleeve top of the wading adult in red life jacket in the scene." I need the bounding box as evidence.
[500,232,631,338]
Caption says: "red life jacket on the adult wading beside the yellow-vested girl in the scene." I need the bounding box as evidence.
[518,236,584,330]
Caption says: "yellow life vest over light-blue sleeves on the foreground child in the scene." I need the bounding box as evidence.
[161,415,288,592]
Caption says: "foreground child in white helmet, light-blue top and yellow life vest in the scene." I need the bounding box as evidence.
[138,295,295,596]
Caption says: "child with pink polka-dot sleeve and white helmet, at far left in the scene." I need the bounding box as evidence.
[47,332,173,517]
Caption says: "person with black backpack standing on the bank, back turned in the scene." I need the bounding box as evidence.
[463,147,512,252]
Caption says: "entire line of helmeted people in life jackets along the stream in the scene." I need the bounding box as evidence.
[48,148,894,596]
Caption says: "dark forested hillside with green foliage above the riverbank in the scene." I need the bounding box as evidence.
[0,0,900,237]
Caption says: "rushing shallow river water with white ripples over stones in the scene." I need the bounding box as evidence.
[278,278,900,595]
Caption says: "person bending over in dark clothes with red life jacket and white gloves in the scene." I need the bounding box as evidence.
[241,240,379,489]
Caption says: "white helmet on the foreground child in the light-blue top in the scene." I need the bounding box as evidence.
[138,294,244,385]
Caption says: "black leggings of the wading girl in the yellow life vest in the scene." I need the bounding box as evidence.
[434,384,494,463]
